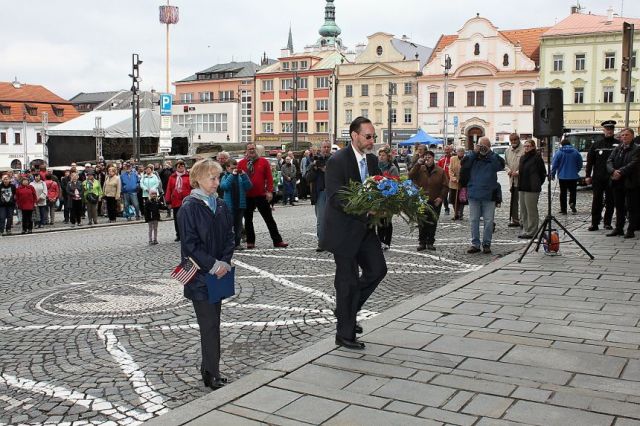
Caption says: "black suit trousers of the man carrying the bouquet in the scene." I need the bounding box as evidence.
[336,230,387,340]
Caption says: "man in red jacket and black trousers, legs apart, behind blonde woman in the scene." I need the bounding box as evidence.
[238,142,289,249]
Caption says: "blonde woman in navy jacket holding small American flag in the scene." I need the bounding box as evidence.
[178,159,234,390]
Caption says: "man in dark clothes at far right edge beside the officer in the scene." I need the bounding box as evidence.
[607,128,640,238]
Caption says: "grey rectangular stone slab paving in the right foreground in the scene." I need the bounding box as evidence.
[150,218,640,426]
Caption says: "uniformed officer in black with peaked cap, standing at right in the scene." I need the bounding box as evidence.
[585,120,618,231]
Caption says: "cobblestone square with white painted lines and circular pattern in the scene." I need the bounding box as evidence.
[0,174,590,425]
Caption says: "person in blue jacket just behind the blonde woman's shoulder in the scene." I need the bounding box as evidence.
[220,159,252,250]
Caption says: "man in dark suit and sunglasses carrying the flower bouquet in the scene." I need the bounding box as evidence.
[320,117,387,349]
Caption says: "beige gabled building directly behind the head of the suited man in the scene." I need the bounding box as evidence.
[336,32,432,143]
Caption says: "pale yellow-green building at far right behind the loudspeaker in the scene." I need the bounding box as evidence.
[540,9,640,130]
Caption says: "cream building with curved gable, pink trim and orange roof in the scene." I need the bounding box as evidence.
[418,16,548,147]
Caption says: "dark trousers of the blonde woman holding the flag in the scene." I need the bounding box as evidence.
[192,300,222,378]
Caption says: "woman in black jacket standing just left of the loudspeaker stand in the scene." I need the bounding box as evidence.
[518,139,547,239]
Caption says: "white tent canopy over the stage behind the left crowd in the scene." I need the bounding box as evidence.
[48,109,189,139]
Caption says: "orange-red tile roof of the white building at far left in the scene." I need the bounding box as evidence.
[0,82,80,123]
